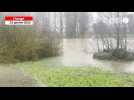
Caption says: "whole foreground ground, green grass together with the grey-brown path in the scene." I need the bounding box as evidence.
[0,57,134,87]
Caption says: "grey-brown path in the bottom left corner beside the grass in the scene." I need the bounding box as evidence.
[0,65,40,87]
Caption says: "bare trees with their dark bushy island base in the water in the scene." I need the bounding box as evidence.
[93,12,134,60]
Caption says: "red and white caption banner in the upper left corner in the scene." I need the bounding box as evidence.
[4,16,33,25]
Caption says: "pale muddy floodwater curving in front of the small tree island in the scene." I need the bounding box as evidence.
[62,39,134,72]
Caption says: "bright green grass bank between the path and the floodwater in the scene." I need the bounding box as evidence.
[16,58,134,87]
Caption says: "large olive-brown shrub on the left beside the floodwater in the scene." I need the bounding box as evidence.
[0,26,61,63]
